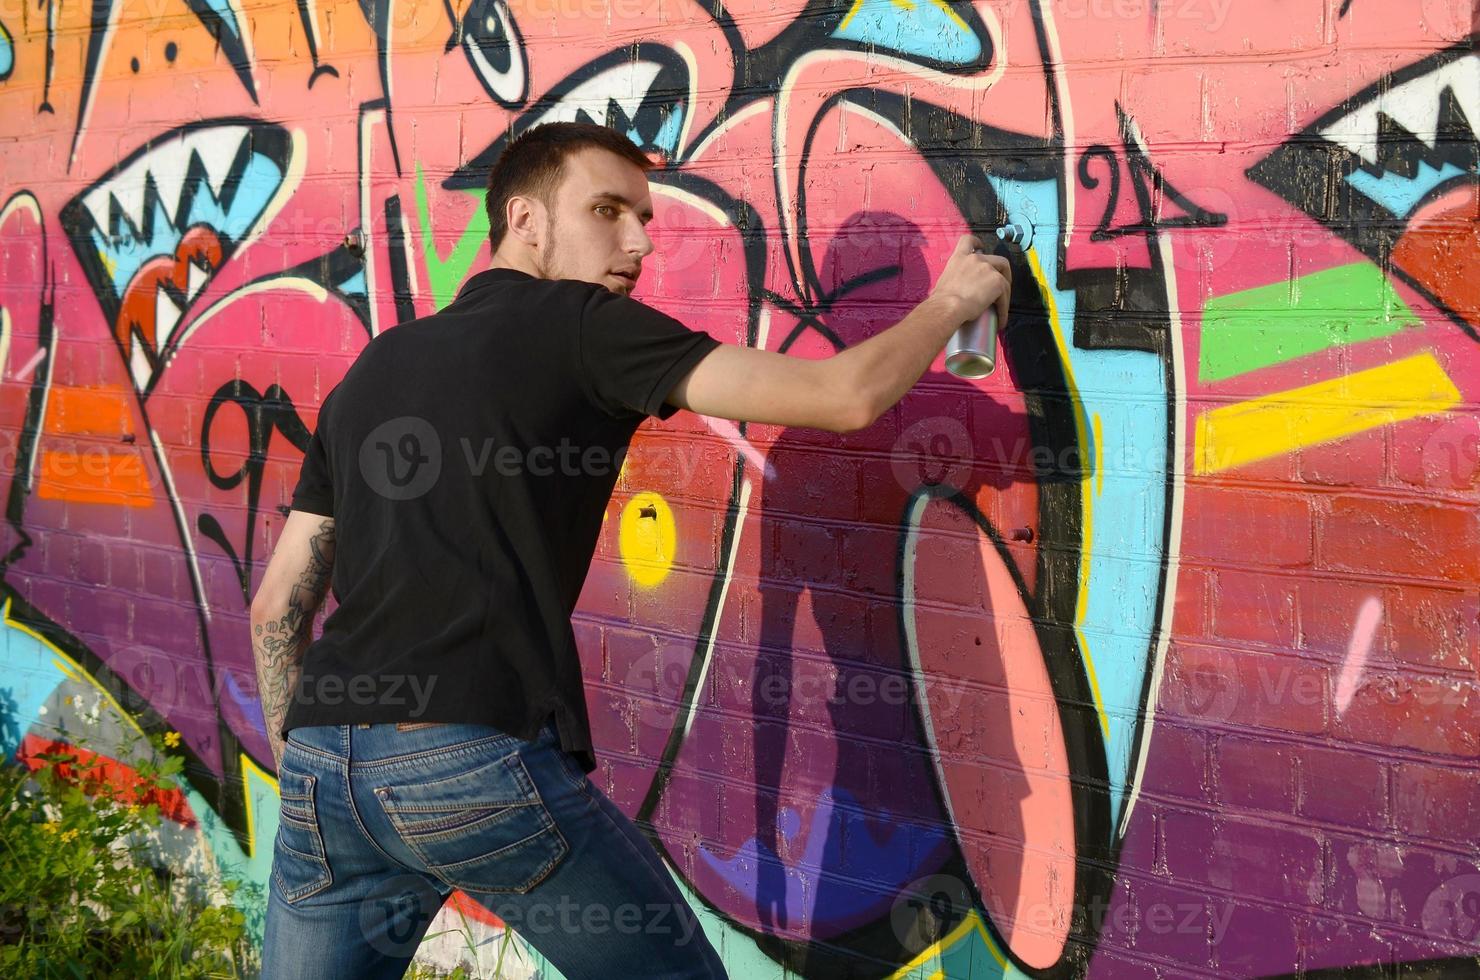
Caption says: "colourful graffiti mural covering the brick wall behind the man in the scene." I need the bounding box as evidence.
[0,0,1480,979]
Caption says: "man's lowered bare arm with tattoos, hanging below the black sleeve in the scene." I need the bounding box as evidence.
[252,511,334,767]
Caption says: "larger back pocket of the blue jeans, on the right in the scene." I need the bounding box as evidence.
[376,752,570,894]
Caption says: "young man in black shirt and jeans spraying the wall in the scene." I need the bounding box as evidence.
[252,123,1011,980]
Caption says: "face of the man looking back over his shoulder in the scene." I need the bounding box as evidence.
[529,147,653,296]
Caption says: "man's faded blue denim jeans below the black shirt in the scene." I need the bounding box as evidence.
[262,722,725,980]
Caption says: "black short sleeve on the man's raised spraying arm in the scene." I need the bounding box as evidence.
[579,289,721,419]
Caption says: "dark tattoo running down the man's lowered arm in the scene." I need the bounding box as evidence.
[252,518,334,764]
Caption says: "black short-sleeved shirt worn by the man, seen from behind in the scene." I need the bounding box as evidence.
[281,269,719,771]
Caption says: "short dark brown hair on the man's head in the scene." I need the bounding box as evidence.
[482,123,653,252]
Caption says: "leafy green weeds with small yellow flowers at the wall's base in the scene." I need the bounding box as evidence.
[0,733,256,979]
